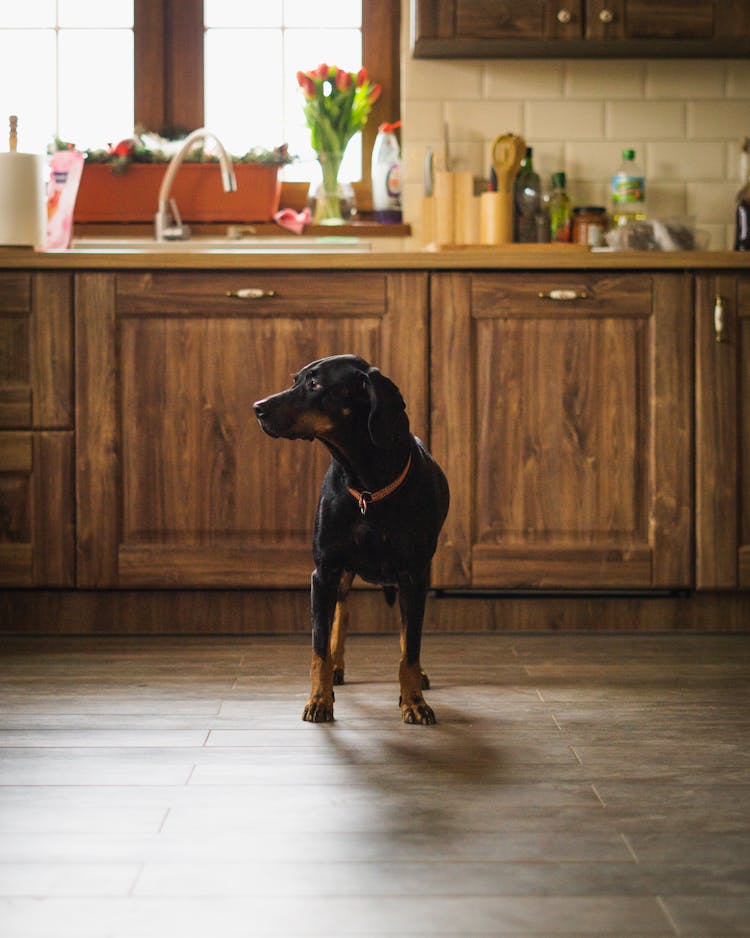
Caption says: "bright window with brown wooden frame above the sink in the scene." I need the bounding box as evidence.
[0,0,400,179]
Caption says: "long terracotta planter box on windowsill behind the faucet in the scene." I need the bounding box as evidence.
[75,163,281,222]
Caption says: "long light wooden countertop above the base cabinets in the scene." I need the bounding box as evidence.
[0,244,750,271]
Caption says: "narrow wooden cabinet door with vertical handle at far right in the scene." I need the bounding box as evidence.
[695,274,750,589]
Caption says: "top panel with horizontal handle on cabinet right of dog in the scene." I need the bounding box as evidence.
[471,272,652,319]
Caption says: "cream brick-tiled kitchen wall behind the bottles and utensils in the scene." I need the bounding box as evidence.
[401,0,750,249]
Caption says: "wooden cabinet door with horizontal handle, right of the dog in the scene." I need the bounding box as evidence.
[431,273,692,589]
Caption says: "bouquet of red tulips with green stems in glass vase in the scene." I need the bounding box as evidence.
[297,63,381,224]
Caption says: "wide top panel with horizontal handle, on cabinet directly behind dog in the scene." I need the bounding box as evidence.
[116,270,386,317]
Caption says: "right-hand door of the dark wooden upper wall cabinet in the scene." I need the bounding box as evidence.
[586,0,750,41]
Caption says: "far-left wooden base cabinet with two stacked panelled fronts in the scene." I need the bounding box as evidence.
[0,271,75,587]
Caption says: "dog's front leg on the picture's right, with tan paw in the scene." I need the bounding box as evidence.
[398,576,436,723]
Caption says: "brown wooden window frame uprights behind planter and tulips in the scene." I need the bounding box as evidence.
[134,0,401,180]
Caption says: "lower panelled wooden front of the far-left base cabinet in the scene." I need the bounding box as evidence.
[0,431,75,586]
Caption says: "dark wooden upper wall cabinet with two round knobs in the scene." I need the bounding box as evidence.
[412,0,750,58]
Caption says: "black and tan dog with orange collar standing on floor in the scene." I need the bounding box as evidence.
[253,355,449,723]
